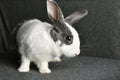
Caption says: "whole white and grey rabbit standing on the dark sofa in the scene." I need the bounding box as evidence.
[16,0,88,74]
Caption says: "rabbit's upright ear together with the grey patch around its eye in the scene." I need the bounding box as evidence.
[47,0,77,45]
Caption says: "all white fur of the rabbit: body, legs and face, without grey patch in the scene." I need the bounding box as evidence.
[17,19,80,73]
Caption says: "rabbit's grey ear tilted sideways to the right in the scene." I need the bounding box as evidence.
[65,9,88,25]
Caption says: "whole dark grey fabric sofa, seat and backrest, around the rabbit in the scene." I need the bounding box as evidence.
[0,0,120,80]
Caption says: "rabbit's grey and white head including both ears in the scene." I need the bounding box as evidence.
[47,0,88,57]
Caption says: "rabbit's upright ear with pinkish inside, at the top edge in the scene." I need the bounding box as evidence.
[47,0,64,22]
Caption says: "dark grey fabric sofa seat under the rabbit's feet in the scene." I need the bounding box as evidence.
[0,55,120,80]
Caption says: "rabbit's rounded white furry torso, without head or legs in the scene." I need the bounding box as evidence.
[17,19,59,61]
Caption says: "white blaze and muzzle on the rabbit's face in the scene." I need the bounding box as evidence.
[61,23,80,57]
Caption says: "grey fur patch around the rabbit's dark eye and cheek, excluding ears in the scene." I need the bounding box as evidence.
[50,24,73,45]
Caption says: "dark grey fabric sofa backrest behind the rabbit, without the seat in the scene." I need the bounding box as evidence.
[0,0,120,58]
